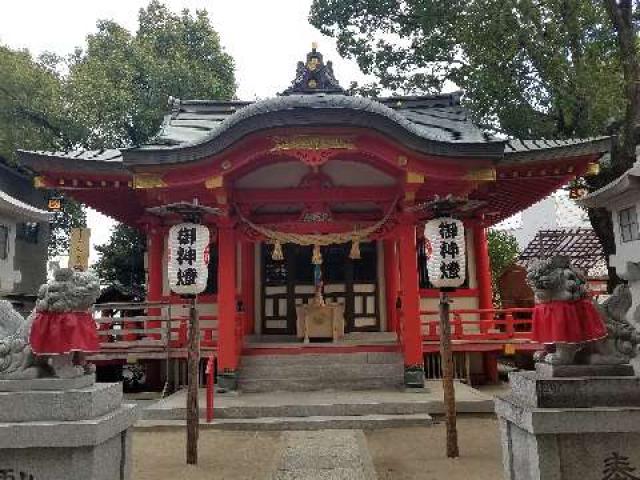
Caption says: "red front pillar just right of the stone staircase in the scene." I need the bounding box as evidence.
[399,225,424,381]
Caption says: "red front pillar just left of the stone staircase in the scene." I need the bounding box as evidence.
[218,225,239,380]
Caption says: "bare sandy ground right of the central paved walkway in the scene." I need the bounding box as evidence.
[365,416,503,480]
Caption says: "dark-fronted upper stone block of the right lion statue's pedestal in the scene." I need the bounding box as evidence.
[509,371,640,408]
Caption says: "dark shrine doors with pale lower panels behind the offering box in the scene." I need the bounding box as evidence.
[261,242,380,335]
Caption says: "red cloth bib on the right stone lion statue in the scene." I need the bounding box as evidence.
[533,298,607,343]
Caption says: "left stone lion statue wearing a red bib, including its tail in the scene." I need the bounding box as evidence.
[0,268,100,380]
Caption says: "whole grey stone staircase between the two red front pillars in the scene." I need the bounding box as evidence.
[238,352,404,393]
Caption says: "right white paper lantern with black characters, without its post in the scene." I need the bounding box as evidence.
[424,217,467,288]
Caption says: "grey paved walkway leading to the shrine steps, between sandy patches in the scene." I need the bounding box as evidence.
[271,430,377,480]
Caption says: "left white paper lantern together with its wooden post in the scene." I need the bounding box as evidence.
[167,221,209,465]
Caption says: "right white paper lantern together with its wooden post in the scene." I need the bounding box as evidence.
[424,216,466,458]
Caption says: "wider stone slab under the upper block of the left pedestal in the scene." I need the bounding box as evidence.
[0,404,138,451]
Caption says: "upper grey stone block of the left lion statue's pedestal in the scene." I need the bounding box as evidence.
[0,383,122,422]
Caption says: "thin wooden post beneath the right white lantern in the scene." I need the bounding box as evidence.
[440,289,460,458]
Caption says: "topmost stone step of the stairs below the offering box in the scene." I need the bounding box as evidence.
[240,352,402,368]
